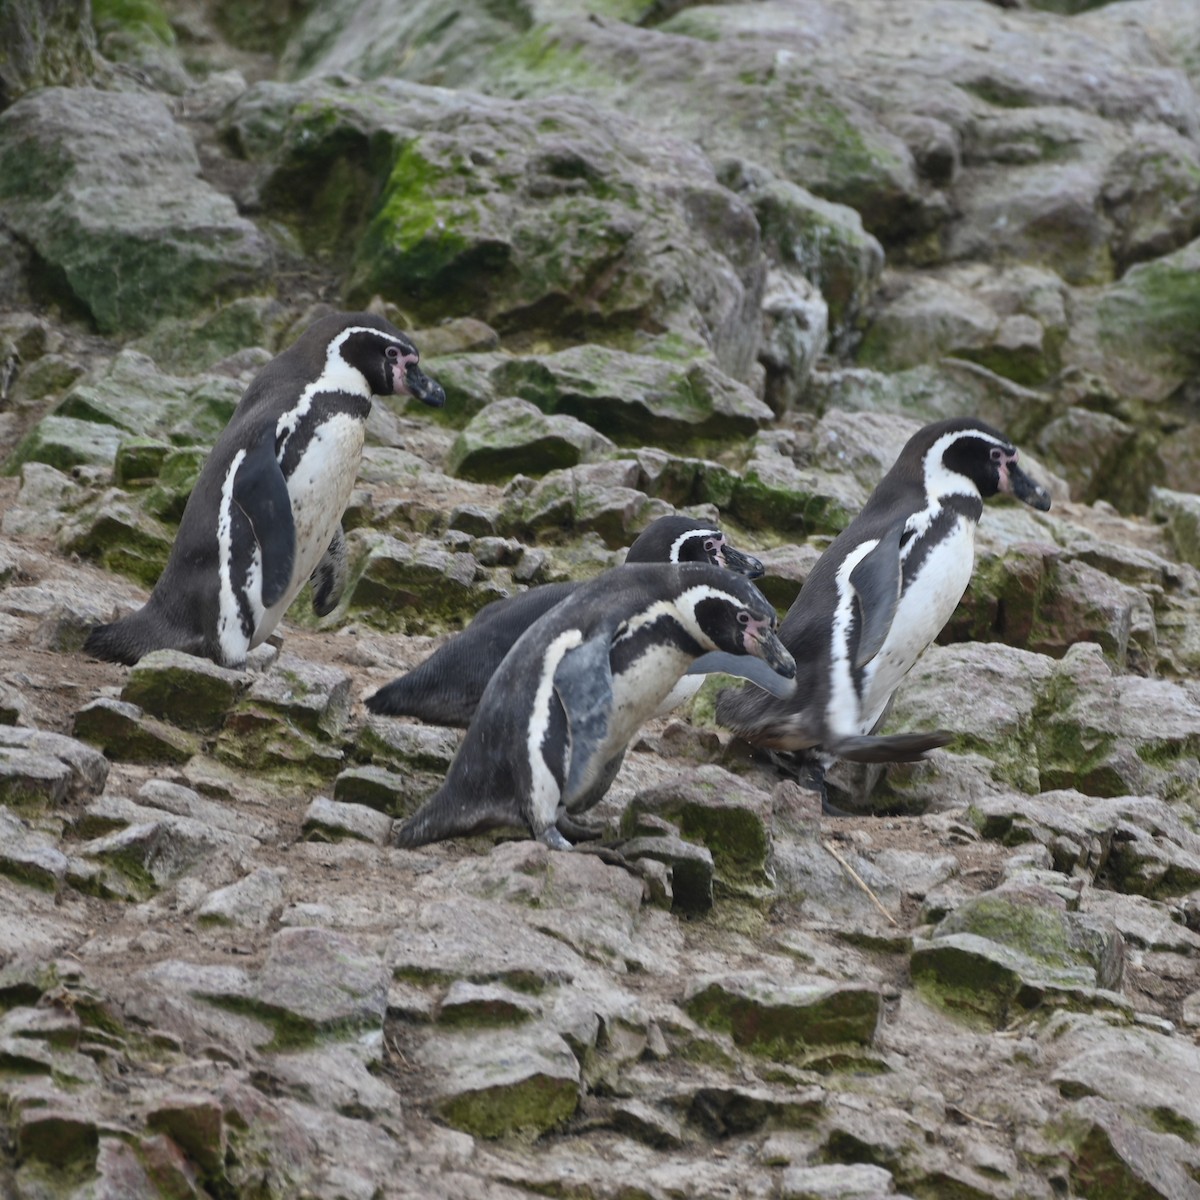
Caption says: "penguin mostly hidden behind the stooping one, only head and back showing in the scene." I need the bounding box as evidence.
[366,516,763,728]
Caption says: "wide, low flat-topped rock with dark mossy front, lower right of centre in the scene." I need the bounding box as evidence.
[685,973,882,1062]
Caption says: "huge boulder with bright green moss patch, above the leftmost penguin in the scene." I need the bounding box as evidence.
[228,80,764,376]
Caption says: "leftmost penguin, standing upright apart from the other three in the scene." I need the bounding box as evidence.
[84,312,445,667]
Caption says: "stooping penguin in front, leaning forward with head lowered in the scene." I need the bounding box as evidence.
[394,563,796,850]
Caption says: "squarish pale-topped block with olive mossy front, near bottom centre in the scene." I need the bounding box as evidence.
[419,1028,580,1138]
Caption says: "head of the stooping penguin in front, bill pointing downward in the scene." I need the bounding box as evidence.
[676,565,796,679]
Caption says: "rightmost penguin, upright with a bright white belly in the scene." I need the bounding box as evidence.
[716,418,1050,764]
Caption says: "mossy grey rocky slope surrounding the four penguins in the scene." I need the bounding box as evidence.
[0,0,1200,1200]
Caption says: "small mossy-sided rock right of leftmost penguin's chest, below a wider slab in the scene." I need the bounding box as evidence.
[446,400,616,482]
